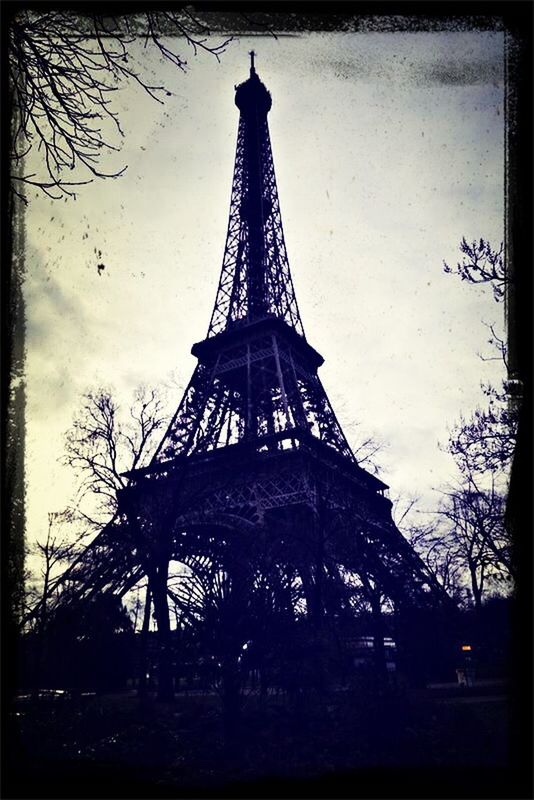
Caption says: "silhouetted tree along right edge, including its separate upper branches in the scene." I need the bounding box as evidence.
[440,237,518,609]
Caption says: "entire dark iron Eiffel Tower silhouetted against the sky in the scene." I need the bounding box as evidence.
[52,52,454,695]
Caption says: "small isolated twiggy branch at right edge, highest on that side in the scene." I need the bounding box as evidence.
[443,236,507,303]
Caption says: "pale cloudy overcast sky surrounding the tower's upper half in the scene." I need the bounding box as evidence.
[24,32,504,539]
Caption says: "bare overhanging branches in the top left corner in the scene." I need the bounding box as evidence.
[9,7,231,202]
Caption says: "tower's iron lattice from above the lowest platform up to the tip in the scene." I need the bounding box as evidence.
[153,68,354,464]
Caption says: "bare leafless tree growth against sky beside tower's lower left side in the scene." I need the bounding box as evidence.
[23,387,167,629]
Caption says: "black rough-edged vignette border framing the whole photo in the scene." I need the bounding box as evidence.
[1,0,534,800]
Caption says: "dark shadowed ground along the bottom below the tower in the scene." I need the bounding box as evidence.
[4,684,511,798]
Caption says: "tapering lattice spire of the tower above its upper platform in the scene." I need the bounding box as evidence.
[208,57,304,336]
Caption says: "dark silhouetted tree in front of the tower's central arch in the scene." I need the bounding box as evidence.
[169,544,301,727]
